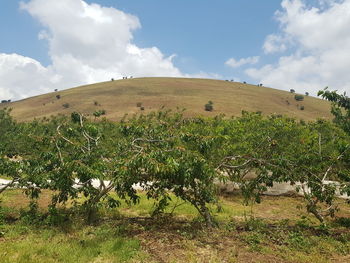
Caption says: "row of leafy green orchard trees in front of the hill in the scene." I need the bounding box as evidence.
[0,92,350,225]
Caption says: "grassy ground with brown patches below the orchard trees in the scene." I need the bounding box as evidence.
[0,190,350,263]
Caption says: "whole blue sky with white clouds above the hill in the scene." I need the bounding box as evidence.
[0,0,350,100]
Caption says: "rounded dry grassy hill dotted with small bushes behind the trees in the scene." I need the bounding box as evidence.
[0,78,331,121]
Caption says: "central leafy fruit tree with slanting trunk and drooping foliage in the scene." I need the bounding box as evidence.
[115,112,220,226]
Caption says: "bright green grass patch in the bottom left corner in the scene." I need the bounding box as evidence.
[0,224,142,263]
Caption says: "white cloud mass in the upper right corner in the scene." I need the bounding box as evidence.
[246,0,350,95]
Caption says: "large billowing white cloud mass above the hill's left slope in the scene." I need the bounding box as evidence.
[0,0,183,99]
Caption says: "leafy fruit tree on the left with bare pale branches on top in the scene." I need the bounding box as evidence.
[39,113,118,222]
